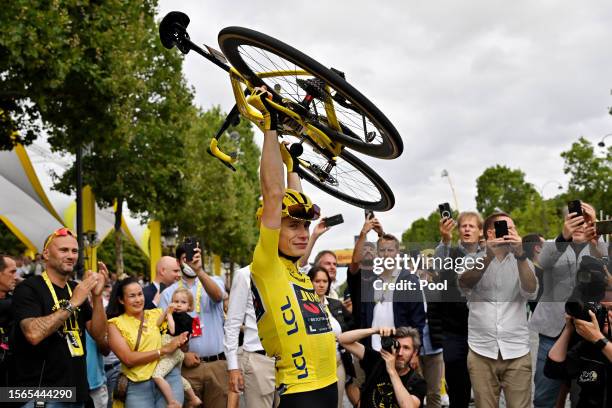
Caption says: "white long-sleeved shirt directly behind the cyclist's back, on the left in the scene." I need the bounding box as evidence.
[223,266,263,370]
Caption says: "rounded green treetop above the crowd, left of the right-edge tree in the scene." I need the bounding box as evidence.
[476,165,538,217]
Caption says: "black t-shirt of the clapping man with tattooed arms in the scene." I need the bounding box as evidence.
[13,276,92,402]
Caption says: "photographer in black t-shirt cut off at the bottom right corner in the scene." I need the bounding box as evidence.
[544,258,612,408]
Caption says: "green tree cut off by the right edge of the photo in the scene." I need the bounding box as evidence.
[561,137,612,216]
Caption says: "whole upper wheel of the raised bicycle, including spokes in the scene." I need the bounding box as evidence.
[219,27,403,159]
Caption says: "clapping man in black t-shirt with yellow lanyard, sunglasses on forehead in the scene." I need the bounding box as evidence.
[13,228,108,407]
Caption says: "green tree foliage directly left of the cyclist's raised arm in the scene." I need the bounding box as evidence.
[170,107,260,264]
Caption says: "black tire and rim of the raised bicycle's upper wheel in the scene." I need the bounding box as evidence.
[219,27,403,159]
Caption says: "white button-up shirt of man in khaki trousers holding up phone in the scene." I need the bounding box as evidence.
[464,253,538,360]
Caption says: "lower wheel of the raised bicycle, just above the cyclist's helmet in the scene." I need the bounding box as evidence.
[283,136,395,211]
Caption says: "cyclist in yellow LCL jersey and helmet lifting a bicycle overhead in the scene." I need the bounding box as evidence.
[249,88,338,408]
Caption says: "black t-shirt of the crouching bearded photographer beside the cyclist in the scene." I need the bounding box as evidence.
[361,347,427,408]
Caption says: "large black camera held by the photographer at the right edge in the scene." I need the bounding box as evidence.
[565,255,608,327]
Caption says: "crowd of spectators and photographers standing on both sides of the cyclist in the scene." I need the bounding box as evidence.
[0,194,612,408]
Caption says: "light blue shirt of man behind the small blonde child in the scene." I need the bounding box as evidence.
[159,276,225,357]
